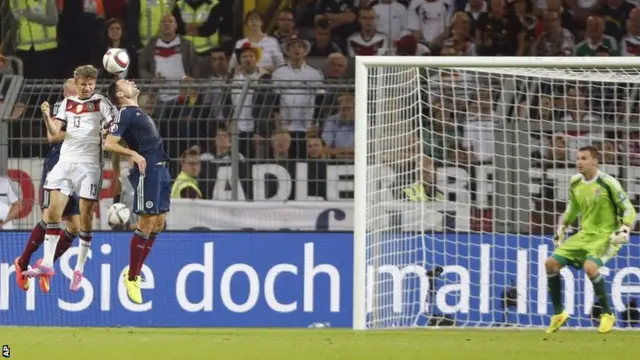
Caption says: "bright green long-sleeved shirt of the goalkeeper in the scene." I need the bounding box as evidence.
[563,171,636,234]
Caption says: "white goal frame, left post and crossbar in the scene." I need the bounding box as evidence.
[352,56,640,330]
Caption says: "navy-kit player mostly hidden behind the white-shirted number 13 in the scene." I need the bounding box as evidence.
[15,78,80,293]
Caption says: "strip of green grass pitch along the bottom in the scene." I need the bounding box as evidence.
[0,327,640,360]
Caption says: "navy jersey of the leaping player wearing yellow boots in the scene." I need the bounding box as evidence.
[109,106,169,164]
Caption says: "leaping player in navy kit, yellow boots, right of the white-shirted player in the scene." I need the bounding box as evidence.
[104,80,171,304]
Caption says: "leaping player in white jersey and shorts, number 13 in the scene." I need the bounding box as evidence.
[23,65,116,291]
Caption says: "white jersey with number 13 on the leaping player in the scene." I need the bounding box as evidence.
[56,94,116,164]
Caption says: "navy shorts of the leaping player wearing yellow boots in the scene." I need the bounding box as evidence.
[129,164,171,215]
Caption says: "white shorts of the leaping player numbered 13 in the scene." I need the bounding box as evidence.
[44,163,102,200]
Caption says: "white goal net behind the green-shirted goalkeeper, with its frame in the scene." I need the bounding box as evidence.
[354,57,640,329]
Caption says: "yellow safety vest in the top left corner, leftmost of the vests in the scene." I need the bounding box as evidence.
[11,0,58,51]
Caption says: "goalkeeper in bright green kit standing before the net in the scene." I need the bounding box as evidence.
[545,146,636,333]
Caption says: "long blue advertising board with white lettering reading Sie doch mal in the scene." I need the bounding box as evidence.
[0,232,640,327]
